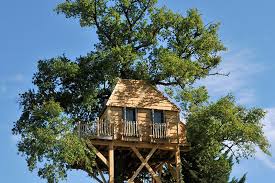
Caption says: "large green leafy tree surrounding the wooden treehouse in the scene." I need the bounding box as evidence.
[13,0,269,183]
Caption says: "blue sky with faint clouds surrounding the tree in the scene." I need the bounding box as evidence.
[0,0,275,183]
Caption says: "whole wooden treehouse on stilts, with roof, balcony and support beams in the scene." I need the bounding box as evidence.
[78,79,189,183]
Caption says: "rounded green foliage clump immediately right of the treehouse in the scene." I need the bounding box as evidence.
[184,95,269,183]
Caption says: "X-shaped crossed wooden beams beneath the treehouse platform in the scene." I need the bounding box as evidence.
[128,146,161,183]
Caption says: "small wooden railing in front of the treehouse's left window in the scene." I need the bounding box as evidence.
[122,120,140,137]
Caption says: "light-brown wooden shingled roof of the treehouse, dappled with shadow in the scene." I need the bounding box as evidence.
[106,79,179,111]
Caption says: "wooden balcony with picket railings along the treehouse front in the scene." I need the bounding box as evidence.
[78,119,169,142]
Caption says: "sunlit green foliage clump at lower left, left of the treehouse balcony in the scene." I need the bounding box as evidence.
[13,99,95,182]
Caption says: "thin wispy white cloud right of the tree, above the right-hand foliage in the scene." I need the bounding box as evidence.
[201,50,265,104]
